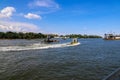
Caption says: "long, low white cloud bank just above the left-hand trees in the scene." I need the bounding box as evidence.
[0,21,40,32]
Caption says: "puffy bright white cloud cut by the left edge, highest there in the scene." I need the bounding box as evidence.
[0,7,16,18]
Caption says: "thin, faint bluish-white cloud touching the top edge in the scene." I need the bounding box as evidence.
[29,0,59,8]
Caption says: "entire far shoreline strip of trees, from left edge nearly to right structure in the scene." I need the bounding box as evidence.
[0,31,102,39]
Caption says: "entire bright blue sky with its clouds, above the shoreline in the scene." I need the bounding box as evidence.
[0,0,120,35]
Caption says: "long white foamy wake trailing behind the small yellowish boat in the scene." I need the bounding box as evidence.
[0,43,80,51]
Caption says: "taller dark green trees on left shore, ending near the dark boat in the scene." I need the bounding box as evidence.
[0,31,46,39]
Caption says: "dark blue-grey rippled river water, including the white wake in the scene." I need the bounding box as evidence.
[0,39,120,80]
